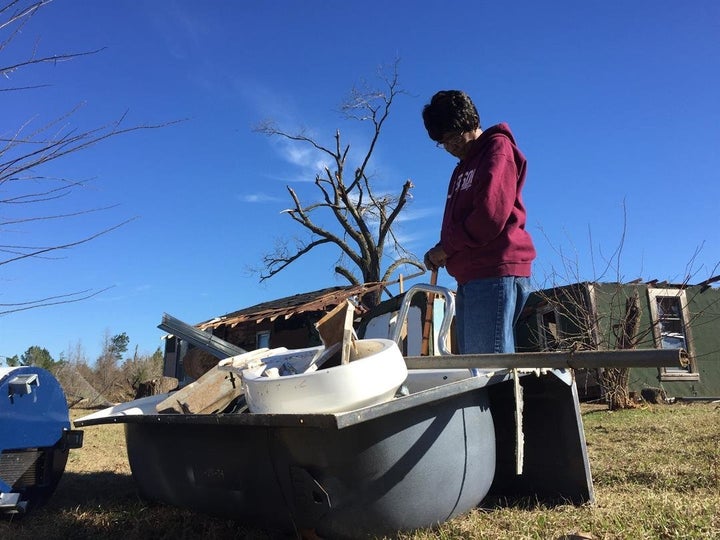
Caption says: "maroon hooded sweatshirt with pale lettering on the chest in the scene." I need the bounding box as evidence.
[440,123,535,285]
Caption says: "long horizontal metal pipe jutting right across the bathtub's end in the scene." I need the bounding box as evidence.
[405,349,688,369]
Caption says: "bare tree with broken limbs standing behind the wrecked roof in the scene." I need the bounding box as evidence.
[257,62,425,306]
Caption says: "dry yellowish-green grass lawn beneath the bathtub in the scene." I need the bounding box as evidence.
[0,403,720,540]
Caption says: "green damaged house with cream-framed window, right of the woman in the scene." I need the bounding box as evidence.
[517,276,720,399]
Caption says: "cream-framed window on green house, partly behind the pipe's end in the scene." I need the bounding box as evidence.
[648,289,700,381]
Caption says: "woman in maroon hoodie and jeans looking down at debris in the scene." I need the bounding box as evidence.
[423,90,535,354]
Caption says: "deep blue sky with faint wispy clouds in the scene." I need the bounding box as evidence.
[0,0,720,361]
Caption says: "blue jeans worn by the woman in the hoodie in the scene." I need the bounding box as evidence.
[455,276,530,354]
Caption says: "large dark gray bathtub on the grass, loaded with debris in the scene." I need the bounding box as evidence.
[76,372,593,538]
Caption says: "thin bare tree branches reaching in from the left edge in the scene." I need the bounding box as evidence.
[0,0,174,315]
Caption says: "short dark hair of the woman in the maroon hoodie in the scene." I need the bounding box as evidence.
[423,90,480,142]
